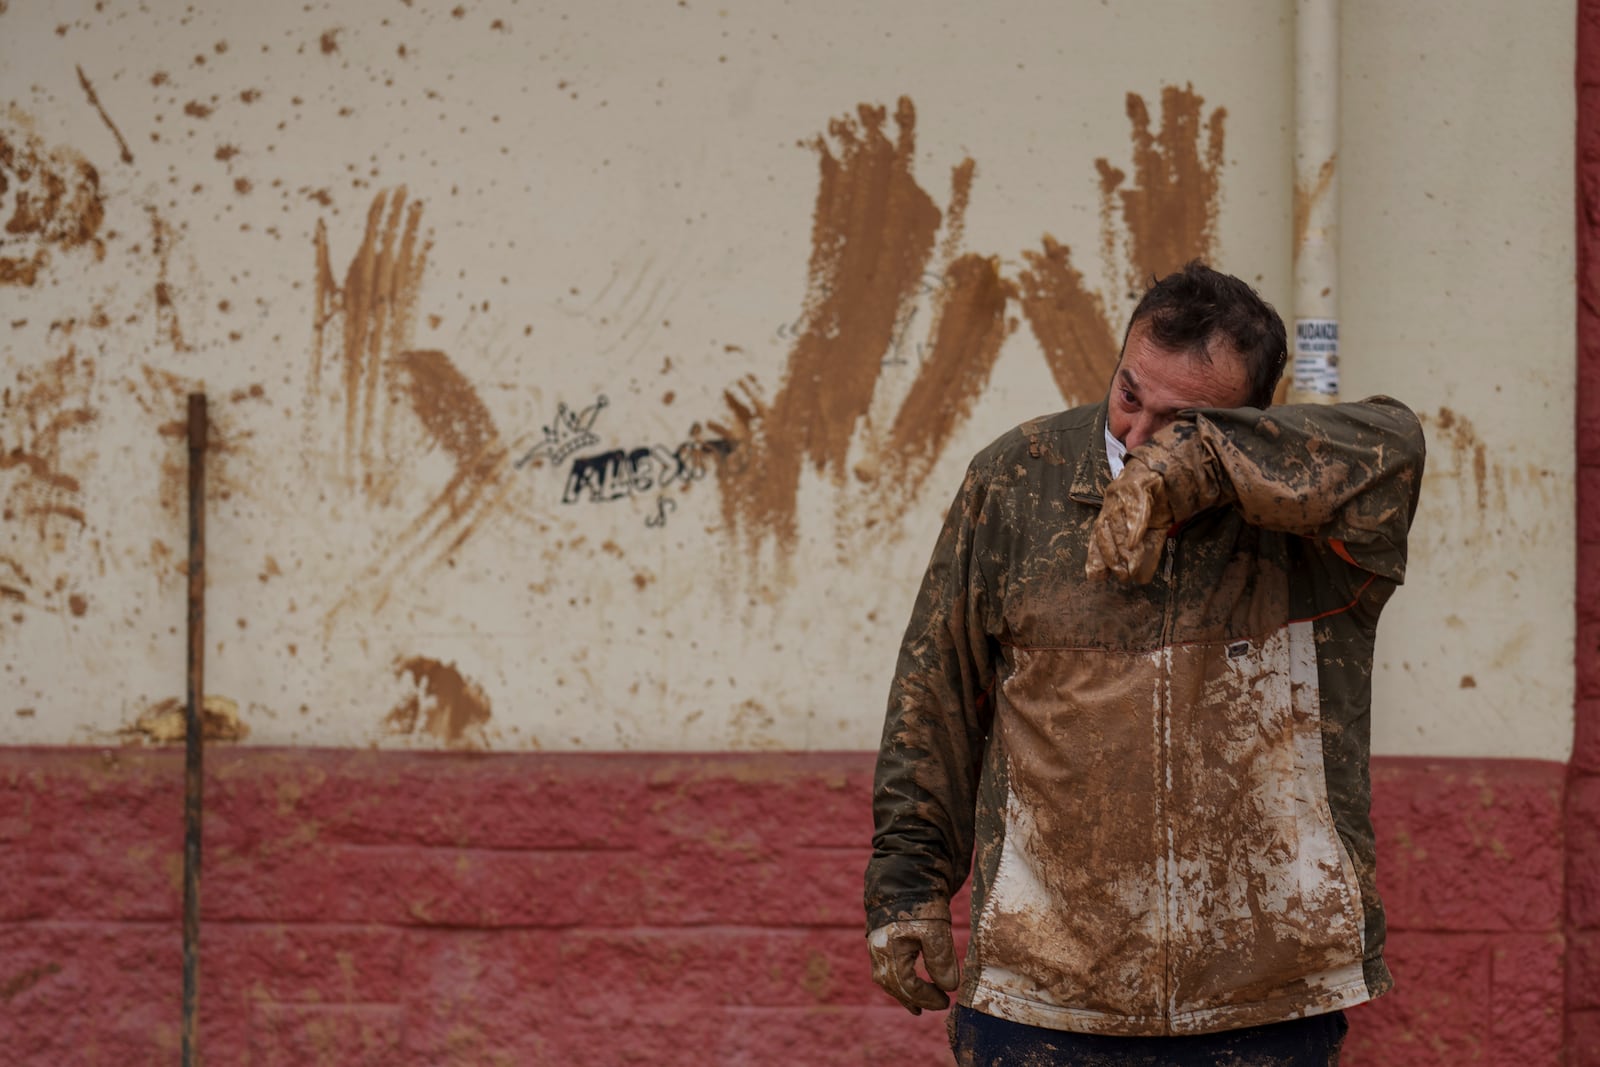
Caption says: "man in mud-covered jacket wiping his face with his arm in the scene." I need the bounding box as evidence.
[866,262,1422,1065]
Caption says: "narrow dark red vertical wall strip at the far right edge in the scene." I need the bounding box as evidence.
[1566,0,1600,1067]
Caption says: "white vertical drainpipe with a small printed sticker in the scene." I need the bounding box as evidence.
[1290,0,1339,403]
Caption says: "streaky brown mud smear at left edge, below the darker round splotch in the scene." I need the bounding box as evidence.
[0,349,96,550]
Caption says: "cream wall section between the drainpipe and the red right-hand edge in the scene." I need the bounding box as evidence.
[1341,2,1578,760]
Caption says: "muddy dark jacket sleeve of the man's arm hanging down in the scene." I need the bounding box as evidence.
[866,461,994,931]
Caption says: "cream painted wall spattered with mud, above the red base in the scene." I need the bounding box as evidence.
[0,0,1573,758]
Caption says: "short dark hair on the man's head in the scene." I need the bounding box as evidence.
[1122,259,1288,408]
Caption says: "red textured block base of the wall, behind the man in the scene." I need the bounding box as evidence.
[0,749,1565,1067]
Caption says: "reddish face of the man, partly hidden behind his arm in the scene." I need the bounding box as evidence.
[1107,323,1250,450]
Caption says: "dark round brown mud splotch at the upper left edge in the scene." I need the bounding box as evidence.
[0,107,106,286]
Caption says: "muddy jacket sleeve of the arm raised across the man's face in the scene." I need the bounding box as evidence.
[1130,397,1424,582]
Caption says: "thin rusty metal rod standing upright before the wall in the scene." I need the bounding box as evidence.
[182,394,206,1067]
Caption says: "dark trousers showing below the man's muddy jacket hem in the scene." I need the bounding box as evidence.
[950,1005,1350,1067]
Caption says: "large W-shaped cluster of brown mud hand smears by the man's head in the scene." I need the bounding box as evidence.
[709,86,1227,572]
